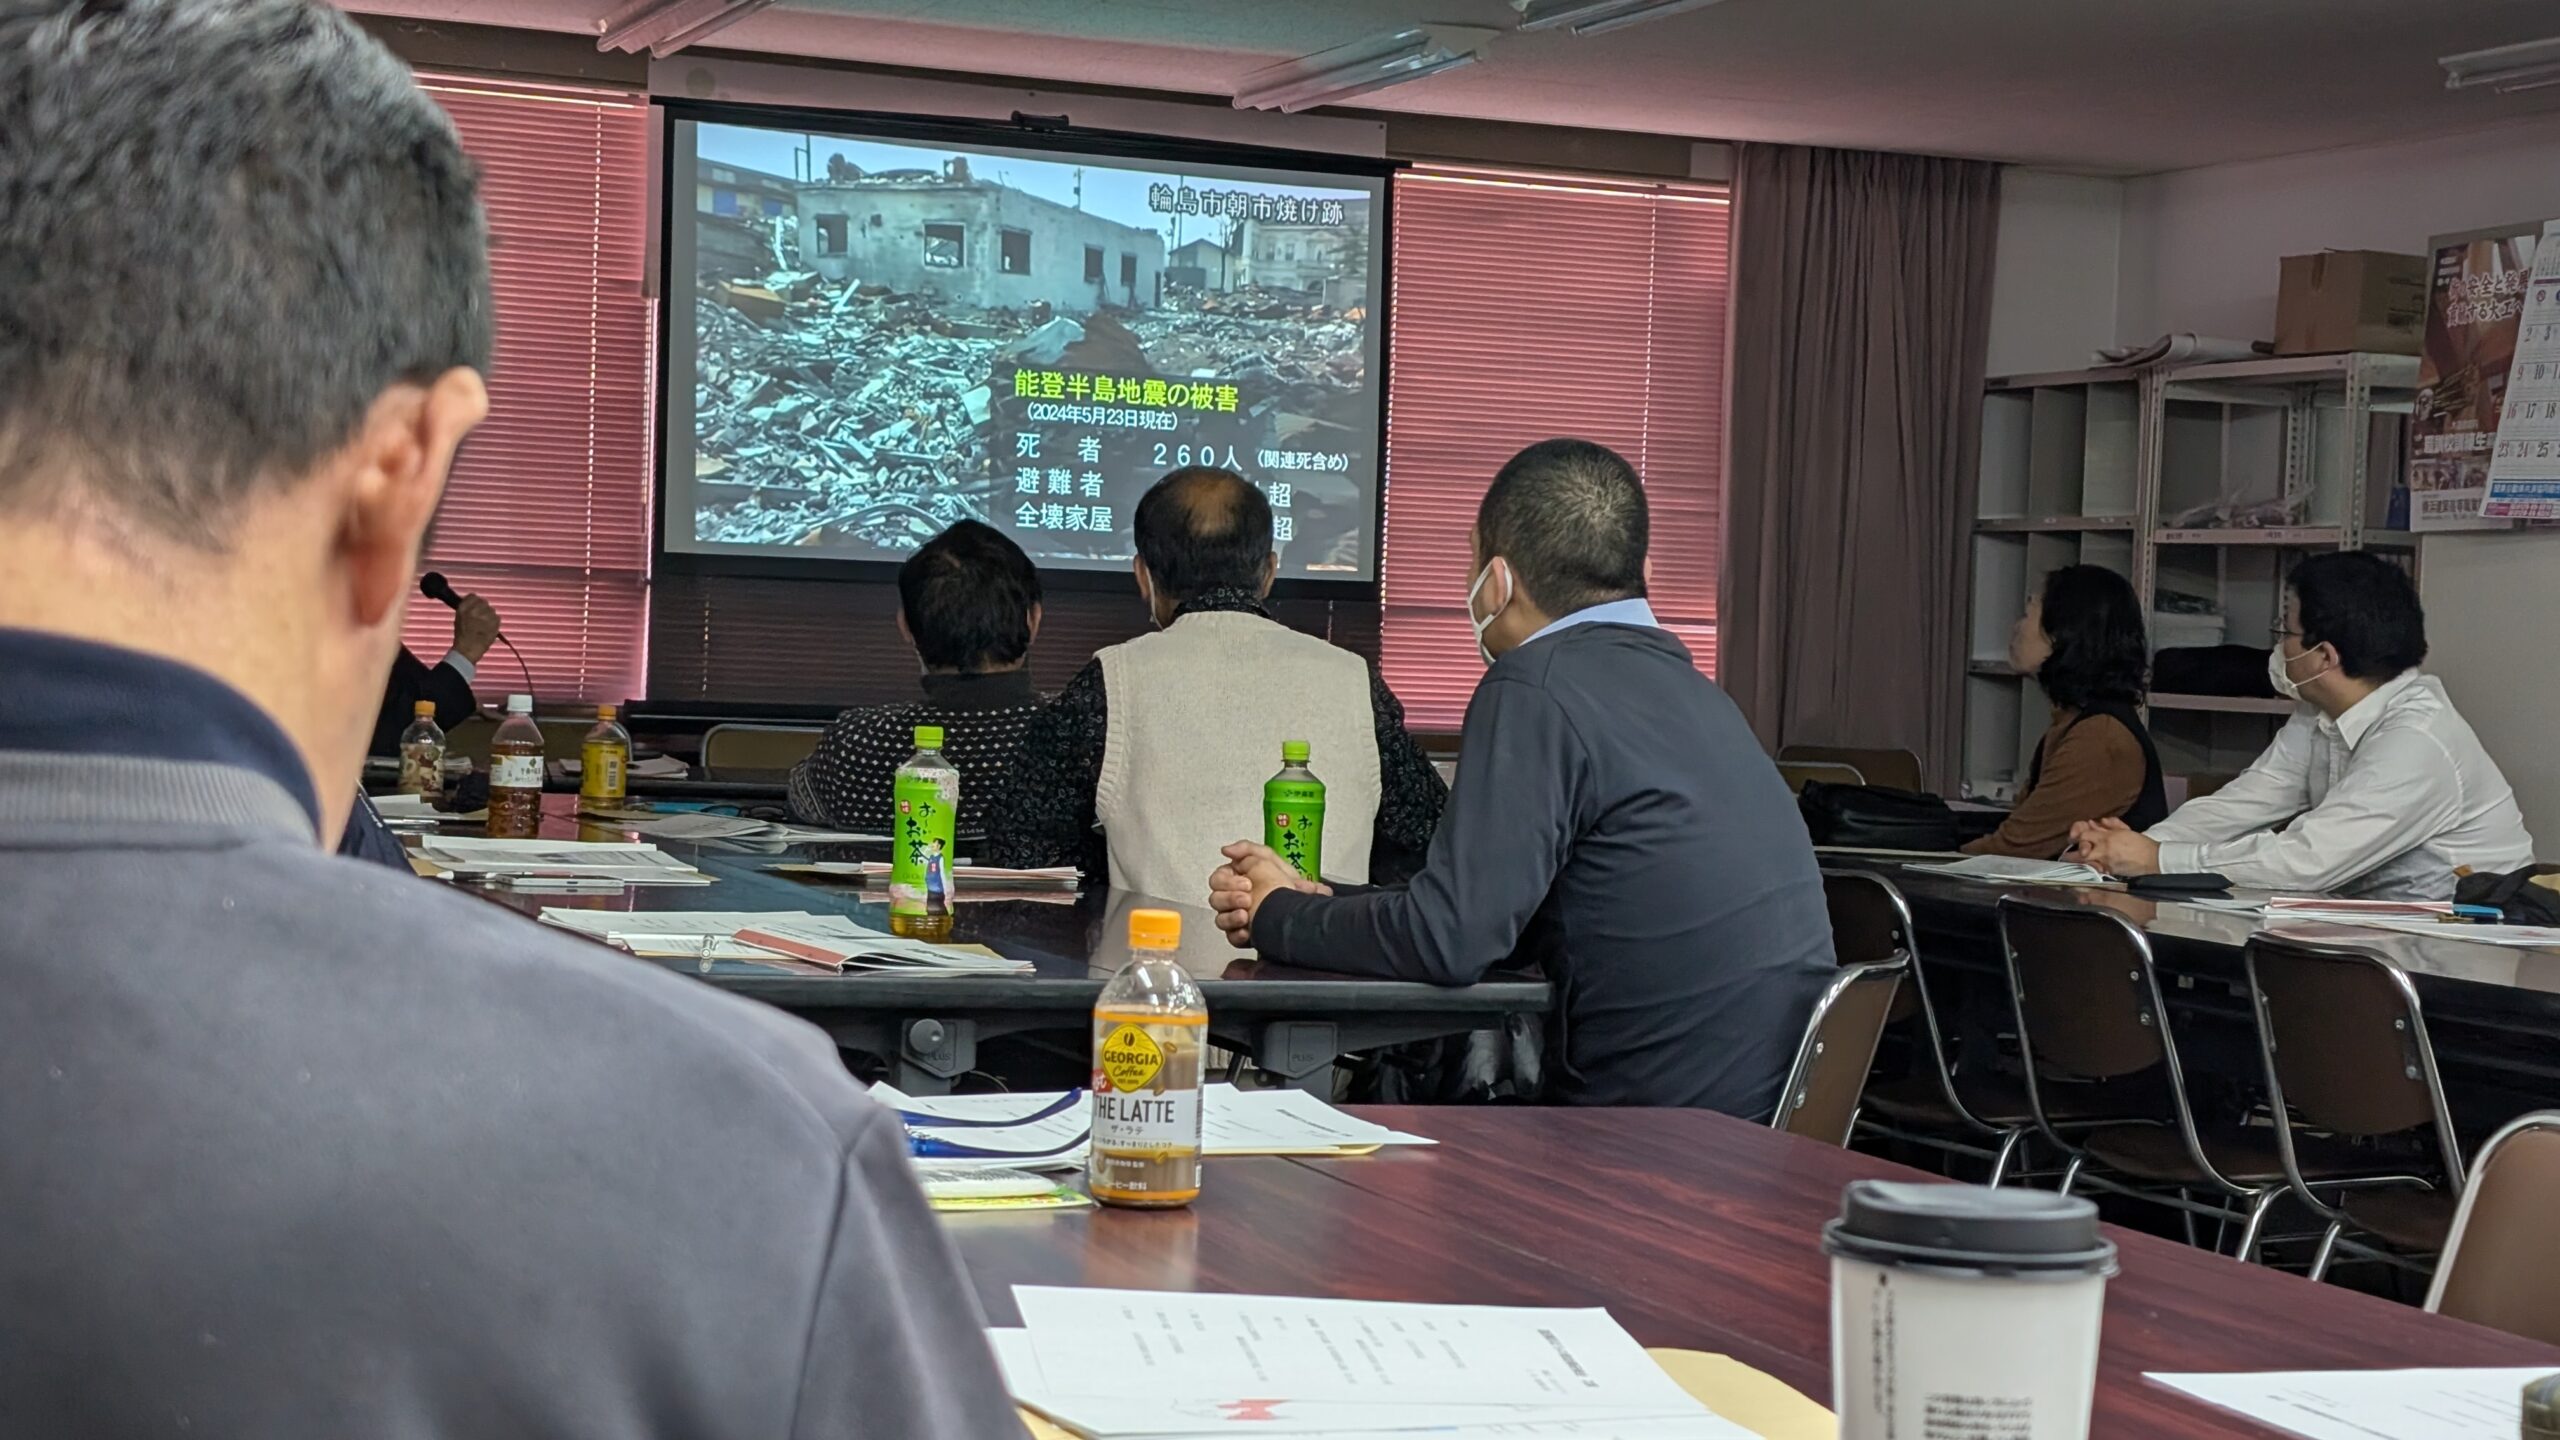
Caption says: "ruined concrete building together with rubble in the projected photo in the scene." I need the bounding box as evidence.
[691,156,1375,559]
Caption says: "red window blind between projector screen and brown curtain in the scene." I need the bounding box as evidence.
[1382,169,1731,730]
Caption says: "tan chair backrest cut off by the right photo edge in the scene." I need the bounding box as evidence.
[2427,1109,2560,1345]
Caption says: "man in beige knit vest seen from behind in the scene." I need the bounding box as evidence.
[980,466,1449,902]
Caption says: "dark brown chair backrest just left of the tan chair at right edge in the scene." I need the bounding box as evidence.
[2243,933,2463,1189]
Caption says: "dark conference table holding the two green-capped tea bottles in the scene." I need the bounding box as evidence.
[424,794,1549,1094]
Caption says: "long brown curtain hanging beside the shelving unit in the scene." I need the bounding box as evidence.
[1718,146,1999,787]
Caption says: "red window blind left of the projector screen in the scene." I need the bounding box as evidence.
[404,74,653,707]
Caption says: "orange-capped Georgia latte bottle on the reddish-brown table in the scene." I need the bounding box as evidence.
[1085,910,1208,1209]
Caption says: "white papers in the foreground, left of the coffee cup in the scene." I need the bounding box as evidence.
[988,1286,1756,1440]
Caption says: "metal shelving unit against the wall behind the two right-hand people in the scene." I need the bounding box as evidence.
[1964,354,2417,799]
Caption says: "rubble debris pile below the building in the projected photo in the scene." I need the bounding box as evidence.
[694,271,1367,556]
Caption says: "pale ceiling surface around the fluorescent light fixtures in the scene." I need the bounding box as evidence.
[343,0,2560,174]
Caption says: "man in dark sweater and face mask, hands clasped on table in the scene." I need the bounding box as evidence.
[1211,441,1838,1120]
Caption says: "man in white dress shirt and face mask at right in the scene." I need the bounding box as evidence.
[2071,551,2534,899]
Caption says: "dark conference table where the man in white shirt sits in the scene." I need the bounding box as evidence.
[1820,851,2560,1133]
